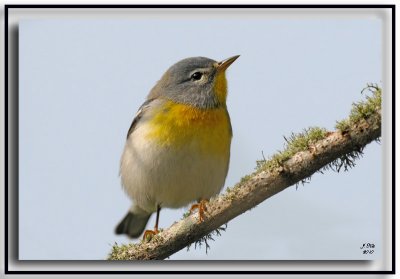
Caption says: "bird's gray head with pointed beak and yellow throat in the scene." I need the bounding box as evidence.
[148,55,239,108]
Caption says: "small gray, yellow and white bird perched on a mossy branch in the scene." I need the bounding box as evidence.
[115,55,239,238]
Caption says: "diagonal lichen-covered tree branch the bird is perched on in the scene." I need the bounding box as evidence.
[109,85,381,260]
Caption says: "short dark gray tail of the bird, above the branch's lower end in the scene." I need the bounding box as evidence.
[115,207,152,238]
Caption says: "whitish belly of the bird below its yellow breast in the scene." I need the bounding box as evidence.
[120,124,229,212]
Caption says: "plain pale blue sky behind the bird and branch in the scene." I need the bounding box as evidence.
[19,13,382,260]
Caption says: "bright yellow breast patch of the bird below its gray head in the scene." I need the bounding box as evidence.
[147,101,232,158]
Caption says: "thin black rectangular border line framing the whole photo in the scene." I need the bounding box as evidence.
[4,4,396,274]
